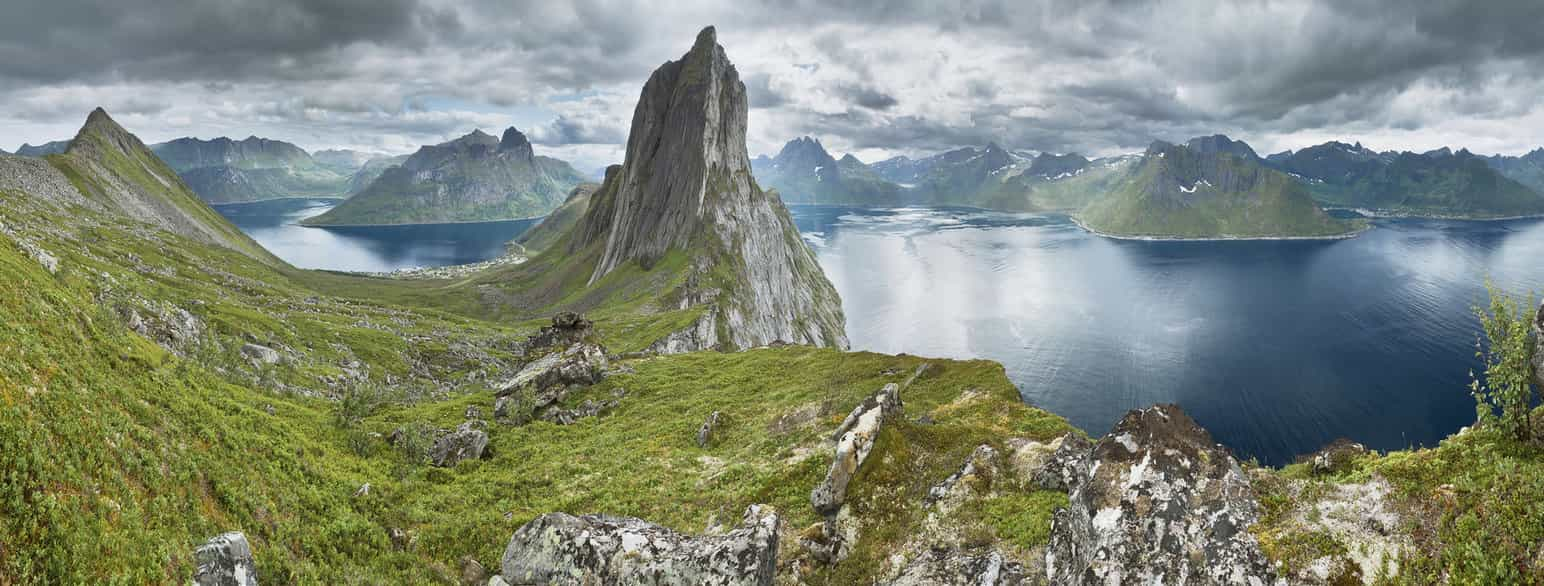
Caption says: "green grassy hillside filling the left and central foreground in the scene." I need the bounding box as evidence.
[0,196,1067,583]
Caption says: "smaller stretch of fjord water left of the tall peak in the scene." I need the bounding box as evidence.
[215,199,537,271]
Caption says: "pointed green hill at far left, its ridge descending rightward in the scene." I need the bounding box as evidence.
[8,108,274,265]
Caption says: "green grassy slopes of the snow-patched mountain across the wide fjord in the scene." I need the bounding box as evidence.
[1079,148,1357,237]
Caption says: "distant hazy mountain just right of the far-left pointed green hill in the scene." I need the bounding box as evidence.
[150,136,347,204]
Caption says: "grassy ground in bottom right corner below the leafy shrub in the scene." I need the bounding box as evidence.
[1252,422,1544,584]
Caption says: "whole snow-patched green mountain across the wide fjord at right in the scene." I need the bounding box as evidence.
[1078,137,1359,239]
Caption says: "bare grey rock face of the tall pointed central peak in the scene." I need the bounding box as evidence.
[568,28,848,352]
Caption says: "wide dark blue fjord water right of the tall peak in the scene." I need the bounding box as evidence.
[794,207,1544,464]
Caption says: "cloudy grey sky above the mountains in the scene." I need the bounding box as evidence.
[0,0,1544,173]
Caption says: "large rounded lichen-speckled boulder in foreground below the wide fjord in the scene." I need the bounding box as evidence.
[1045,406,1277,584]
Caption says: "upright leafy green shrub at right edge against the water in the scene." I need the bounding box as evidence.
[1468,282,1538,440]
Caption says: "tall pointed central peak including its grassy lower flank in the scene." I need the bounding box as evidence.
[482,28,848,353]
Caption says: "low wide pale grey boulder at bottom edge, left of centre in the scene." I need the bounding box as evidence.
[500,504,781,586]
